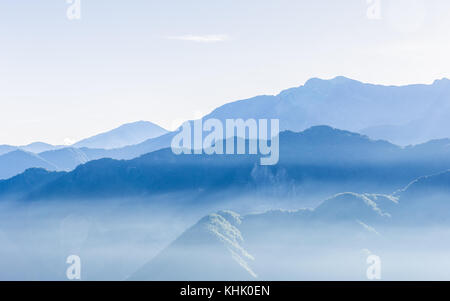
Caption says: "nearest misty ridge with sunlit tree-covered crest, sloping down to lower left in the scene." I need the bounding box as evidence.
[129,172,450,281]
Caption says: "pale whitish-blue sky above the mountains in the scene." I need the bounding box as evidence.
[0,0,450,145]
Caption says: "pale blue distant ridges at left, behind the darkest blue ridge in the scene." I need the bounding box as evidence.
[0,121,170,179]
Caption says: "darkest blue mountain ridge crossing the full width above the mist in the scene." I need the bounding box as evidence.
[0,126,450,203]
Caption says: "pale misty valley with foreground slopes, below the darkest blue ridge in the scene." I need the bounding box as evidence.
[0,174,450,280]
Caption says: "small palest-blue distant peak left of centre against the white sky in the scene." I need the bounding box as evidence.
[72,121,168,149]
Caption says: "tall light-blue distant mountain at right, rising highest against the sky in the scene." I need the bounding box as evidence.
[205,77,450,145]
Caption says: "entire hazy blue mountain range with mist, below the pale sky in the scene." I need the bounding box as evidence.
[0,77,450,280]
